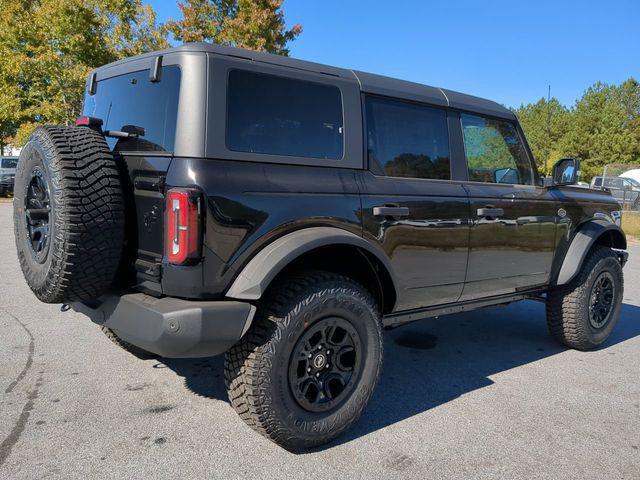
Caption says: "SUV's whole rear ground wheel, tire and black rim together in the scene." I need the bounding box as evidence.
[225,271,382,451]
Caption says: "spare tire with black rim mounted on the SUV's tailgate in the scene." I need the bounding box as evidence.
[13,126,125,303]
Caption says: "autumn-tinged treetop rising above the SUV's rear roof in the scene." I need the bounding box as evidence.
[167,0,302,55]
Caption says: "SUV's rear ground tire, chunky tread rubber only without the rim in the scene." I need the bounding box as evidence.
[224,271,383,452]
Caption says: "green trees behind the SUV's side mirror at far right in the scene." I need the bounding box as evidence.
[515,78,640,180]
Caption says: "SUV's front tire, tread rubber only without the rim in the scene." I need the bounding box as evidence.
[546,246,624,350]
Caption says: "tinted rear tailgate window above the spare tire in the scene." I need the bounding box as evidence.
[83,66,180,152]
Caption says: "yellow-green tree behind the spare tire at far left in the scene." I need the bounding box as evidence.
[0,0,168,144]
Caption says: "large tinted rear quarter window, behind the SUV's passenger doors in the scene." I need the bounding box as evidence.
[226,70,343,160]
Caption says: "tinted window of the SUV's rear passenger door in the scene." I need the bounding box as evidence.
[366,97,451,180]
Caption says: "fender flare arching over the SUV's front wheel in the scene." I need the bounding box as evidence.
[556,220,627,285]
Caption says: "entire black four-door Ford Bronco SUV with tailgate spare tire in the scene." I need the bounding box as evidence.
[14,43,627,450]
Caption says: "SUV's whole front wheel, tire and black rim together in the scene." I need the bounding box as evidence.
[547,247,623,350]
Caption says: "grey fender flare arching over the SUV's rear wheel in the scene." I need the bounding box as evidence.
[226,227,398,300]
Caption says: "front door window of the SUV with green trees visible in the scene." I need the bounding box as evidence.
[460,113,533,185]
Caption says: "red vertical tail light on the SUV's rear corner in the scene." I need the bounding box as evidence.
[165,188,202,265]
